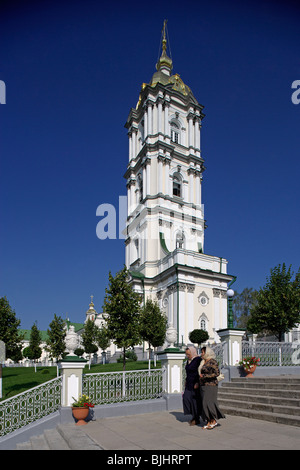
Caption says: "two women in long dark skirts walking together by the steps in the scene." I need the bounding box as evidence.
[183,346,225,429]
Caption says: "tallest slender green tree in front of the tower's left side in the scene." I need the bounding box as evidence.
[103,267,141,370]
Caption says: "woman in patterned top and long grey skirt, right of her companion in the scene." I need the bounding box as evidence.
[199,347,225,429]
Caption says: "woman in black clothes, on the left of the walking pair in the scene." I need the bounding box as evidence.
[182,346,201,426]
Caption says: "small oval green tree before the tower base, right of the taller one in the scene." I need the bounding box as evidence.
[140,299,168,366]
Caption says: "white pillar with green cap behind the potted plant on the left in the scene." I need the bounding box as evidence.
[60,356,87,406]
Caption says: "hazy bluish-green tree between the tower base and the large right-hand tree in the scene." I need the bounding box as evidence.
[232,287,257,328]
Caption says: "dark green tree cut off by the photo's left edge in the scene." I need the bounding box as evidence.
[0,297,24,361]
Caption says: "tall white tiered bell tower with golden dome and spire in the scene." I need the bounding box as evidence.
[124,21,232,343]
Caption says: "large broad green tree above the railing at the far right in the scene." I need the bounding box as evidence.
[247,263,300,341]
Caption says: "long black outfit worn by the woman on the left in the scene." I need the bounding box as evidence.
[182,356,201,422]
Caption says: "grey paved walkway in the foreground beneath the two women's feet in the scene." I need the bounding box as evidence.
[77,410,300,451]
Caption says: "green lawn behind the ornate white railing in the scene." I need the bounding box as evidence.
[0,361,161,401]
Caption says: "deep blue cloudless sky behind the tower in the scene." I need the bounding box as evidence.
[0,0,300,329]
